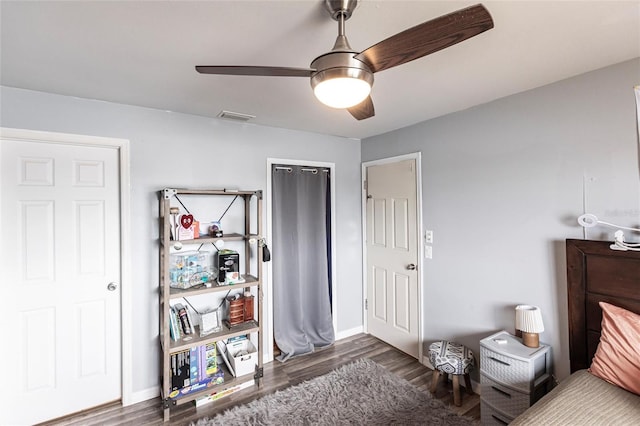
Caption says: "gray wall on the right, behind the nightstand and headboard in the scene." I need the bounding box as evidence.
[362,59,640,378]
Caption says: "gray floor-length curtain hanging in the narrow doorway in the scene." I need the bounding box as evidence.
[271,166,335,362]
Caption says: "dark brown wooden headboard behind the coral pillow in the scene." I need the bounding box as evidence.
[566,240,640,373]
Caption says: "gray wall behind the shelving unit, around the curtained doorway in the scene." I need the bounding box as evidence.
[0,87,362,392]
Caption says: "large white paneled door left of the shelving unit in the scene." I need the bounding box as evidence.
[0,137,122,424]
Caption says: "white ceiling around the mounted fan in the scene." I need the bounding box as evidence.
[0,0,640,138]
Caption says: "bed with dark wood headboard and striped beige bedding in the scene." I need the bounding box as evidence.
[511,240,640,425]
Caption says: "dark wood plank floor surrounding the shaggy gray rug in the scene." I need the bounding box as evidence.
[44,334,480,426]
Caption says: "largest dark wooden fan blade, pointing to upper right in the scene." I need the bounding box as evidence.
[355,4,493,72]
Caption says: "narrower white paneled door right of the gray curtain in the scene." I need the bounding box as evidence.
[366,159,420,358]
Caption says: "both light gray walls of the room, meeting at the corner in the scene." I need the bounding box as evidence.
[0,59,640,392]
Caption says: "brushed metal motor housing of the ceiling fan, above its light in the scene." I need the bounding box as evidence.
[310,51,373,89]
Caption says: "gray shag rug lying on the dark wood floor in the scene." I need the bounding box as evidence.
[192,358,476,426]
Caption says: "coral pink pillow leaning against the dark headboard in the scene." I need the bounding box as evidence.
[589,302,640,395]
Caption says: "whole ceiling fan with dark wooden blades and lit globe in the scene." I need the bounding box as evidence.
[196,0,493,120]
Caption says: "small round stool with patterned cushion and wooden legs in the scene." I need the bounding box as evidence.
[429,340,475,407]
